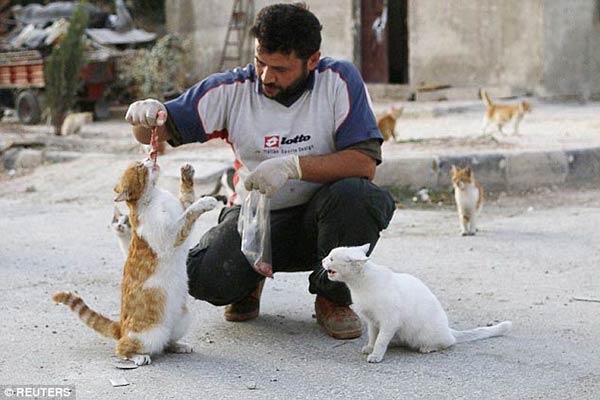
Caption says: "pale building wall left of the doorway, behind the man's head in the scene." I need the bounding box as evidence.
[165,0,354,79]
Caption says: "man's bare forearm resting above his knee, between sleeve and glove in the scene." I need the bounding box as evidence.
[299,150,377,183]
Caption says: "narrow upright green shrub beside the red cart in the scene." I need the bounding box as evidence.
[44,3,88,134]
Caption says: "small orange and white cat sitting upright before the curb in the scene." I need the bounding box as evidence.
[450,165,483,236]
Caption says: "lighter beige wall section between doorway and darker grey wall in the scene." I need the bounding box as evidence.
[408,0,543,88]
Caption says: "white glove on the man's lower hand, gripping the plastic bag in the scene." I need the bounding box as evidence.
[244,155,302,197]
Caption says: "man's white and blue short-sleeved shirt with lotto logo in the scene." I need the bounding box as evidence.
[165,58,382,210]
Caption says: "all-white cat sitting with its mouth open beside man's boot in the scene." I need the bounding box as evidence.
[323,244,512,363]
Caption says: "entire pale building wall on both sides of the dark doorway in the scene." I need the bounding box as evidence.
[166,0,600,98]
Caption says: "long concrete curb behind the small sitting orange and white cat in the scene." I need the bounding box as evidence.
[375,147,600,192]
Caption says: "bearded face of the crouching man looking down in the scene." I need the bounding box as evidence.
[254,42,320,100]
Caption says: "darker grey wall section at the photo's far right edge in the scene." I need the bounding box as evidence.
[539,0,600,99]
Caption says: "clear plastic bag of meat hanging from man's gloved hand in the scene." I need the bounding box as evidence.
[238,190,273,278]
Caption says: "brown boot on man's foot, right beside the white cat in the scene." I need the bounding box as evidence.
[315,295,362,339]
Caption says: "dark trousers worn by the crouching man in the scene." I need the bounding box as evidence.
[187,178,395,306]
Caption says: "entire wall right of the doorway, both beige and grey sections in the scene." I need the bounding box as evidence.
[409,0,600,98]
